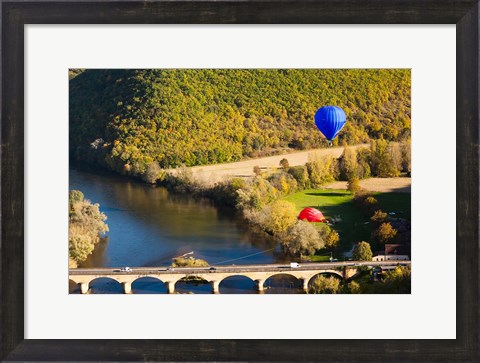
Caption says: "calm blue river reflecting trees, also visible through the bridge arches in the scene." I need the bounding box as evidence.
[69,166,300,294]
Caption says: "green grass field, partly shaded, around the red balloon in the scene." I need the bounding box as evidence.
[283,189,411,251]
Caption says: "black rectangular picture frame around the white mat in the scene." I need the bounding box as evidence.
[0,0,480,362]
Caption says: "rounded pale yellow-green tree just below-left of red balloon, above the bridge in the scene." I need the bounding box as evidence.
[282,221,325,256]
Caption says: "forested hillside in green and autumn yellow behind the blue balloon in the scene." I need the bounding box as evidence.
[69,69,410,175]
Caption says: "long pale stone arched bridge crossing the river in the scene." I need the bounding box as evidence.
[69,261,410,294]
